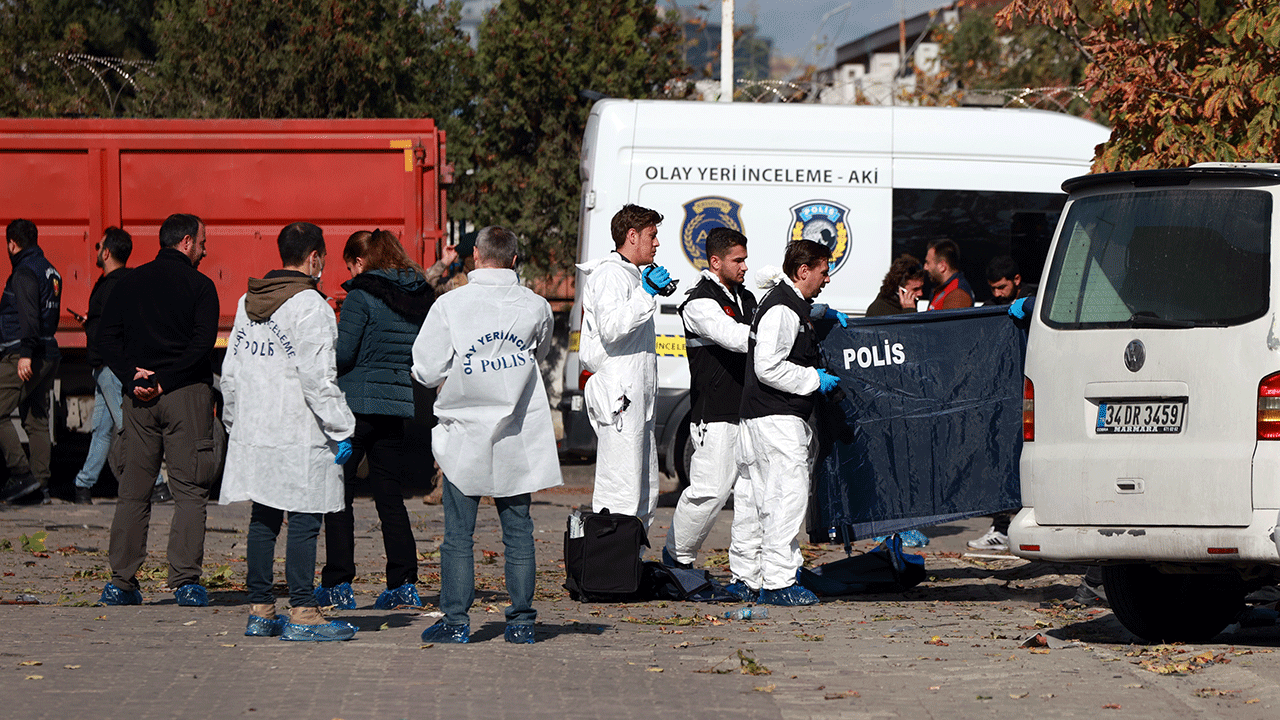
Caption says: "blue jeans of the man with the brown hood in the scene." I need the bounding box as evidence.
[244,502,324,607]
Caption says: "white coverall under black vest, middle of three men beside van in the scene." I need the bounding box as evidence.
[667,270,751,565]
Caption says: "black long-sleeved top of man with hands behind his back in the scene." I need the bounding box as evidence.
[97,247,218,395]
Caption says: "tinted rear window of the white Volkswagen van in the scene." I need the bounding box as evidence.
[1041,188,1271,329]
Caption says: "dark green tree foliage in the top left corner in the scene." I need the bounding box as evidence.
[0,0,155,117]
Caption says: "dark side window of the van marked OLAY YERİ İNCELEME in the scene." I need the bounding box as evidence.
[892,188,1066,302]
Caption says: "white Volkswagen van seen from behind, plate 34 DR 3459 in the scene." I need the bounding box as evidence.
[1009,164,1280,641]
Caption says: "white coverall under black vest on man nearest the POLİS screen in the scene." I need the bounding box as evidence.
[730,278,819,589]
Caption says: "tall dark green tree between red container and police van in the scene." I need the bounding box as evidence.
[467,0,685,275]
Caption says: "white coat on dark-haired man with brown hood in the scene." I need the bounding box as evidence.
[219,290,356,512]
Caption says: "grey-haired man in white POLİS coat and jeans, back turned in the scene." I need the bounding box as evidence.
[413,225,562,644]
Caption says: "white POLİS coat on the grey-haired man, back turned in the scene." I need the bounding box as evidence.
[413,268,563,497]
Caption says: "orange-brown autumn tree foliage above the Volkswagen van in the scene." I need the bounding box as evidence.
[998,0,1280,172]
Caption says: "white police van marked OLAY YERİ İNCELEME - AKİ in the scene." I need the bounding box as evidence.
[559,100,1108,482]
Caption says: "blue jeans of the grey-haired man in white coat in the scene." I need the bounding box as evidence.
[440,478,538,625]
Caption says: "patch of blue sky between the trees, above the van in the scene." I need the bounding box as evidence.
[678,0,951,67]
